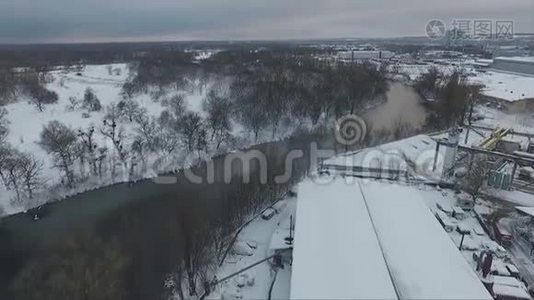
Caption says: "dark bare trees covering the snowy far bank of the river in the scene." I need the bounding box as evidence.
[0,51,394,212]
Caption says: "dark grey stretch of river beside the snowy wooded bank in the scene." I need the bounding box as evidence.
[0,81,430,299]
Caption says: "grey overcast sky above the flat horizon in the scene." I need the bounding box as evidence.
[0,0,534,43]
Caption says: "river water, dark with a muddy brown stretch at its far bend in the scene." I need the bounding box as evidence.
[0,83,426,299]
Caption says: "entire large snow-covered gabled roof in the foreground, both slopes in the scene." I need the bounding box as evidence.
[291,177,491,299]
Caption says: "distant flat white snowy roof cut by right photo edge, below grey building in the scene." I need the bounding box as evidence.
[472,71,534,101]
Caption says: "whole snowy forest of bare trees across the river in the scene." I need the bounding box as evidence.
[0,50,387,214]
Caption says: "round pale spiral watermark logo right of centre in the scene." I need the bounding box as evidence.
[335,115,367,146]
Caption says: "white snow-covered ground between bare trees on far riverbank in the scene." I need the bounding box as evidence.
[0,62,322,214]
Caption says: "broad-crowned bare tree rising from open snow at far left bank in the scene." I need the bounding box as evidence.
[38,121,76,187]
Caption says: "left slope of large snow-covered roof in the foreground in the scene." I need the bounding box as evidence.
[291,180,397,299]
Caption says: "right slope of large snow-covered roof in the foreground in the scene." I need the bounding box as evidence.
[362,182,491,299]
